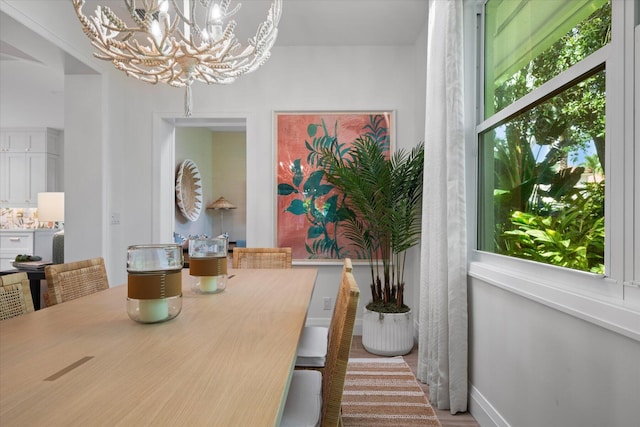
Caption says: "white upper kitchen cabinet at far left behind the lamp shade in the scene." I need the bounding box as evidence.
[0,129,61,208]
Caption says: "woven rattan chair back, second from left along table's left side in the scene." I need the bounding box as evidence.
[44,258,109,307]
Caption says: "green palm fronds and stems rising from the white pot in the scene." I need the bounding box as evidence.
[318,137,424,306]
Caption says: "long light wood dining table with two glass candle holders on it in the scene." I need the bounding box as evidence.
[0,268,317,427]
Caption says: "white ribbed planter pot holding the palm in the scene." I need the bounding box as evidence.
[362,307,413,356]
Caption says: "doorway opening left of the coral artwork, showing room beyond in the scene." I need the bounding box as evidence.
[153,114,251,247]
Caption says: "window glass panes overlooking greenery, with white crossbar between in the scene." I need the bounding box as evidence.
[477,0,612,275]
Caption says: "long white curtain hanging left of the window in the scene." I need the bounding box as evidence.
[418,0,468,414]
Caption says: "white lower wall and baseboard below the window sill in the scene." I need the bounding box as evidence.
[469,279,640,427]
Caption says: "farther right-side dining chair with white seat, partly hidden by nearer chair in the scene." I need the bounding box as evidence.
[296,258,353,371]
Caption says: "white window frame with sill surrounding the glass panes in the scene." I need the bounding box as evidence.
[464,0,640,341]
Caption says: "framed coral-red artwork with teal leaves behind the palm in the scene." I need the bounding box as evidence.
[274,111,395,262]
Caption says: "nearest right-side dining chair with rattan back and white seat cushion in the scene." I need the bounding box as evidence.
[280,260,360,427]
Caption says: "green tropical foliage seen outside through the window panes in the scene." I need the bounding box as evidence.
[479,3,611,273]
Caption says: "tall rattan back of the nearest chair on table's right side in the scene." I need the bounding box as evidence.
[322,259,360,427]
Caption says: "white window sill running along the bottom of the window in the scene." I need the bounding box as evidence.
[469,261,640,341]
